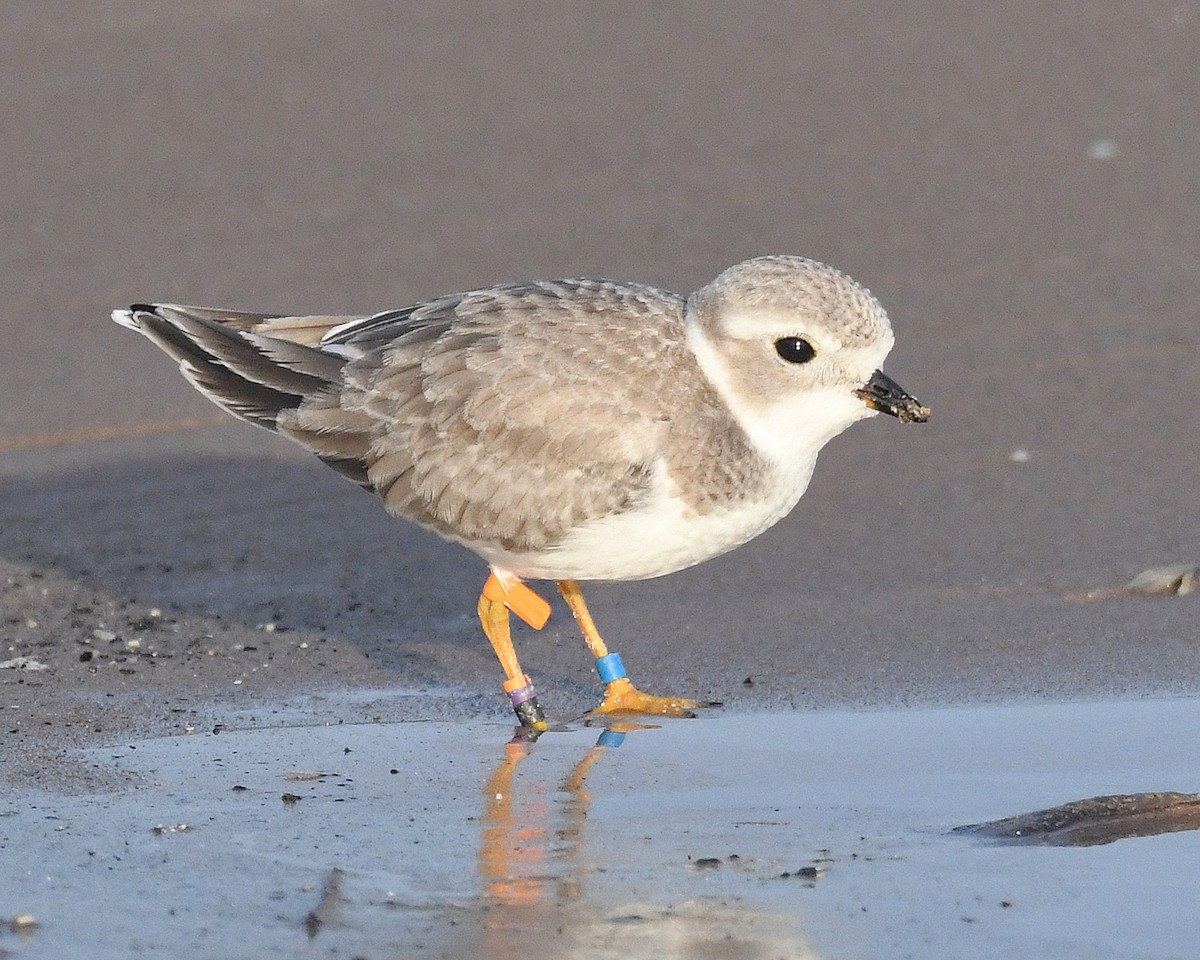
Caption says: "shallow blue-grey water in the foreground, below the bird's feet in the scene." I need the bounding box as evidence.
[0,700,1200,960]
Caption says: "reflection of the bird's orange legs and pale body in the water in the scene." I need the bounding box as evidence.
[468,722,815,960]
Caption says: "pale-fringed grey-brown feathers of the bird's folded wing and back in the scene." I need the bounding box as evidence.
[336,281,684,551]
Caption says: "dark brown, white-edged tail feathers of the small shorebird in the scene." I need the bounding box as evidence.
[113,304,370,486]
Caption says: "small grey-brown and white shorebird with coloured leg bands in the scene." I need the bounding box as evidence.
[112,254,930,731]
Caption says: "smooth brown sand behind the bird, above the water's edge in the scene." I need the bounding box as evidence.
[0,0,1200,708]
